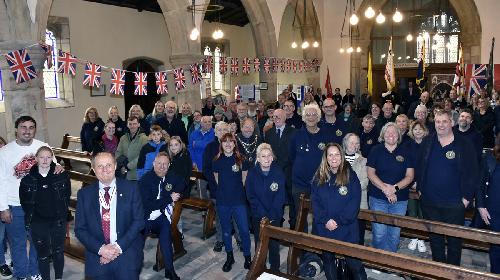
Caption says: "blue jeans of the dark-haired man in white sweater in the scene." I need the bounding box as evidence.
[5,206,39,278]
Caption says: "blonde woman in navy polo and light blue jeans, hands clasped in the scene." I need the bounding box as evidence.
[366,122,414,252]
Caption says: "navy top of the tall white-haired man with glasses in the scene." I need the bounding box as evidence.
[288,127,332,191]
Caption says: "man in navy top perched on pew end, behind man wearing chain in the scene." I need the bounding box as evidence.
[138,152,185,280]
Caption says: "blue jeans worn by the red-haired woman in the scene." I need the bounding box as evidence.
[217,205,251,256]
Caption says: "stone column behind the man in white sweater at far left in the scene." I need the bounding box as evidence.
[0,41,48,142]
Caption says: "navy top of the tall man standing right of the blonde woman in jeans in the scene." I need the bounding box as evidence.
[421,137,462,205]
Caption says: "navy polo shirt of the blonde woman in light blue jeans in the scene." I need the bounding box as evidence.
[366,143,414,201]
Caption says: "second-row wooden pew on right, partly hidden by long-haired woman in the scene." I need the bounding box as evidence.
[287,195,500,273]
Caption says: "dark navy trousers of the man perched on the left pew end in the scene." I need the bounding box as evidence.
[145,215,174,270]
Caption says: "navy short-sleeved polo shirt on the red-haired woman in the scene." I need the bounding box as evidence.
[212,154,248,206]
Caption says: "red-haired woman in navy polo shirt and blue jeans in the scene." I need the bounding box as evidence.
[212,133,252,272]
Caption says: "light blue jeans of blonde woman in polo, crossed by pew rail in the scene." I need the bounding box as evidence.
[369,196,408,252]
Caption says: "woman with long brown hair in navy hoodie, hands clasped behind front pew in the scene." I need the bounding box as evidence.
[311,143,366,280]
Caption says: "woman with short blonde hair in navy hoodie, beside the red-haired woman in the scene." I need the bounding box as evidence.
[245,143,285,272]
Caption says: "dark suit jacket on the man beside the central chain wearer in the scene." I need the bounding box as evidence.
[264,125,295,181]
